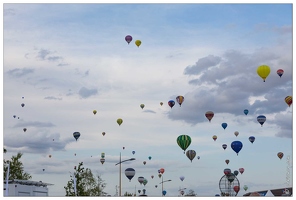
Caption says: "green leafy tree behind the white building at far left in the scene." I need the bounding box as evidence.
[3,152,32,180]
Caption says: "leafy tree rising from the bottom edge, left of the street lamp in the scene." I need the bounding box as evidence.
[64,162,106,196]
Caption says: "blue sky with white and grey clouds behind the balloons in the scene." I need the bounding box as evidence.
[2,2,293,197]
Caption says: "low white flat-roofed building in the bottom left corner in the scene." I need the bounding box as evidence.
[3,179,53,197]
